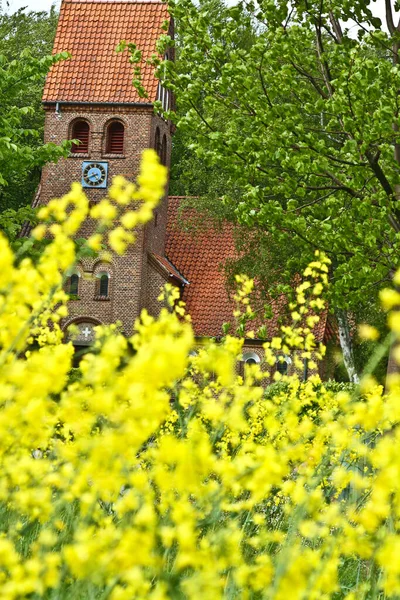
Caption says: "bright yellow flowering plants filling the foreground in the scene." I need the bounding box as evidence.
[0,152,400,600]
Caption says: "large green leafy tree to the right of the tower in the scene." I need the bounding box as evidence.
[150,0,400,378]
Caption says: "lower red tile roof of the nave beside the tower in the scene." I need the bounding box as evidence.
[165,196,327,341]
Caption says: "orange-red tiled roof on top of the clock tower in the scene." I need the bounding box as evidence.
[43,0,169,103]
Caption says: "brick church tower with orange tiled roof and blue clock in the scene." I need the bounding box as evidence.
[40,0,173,345]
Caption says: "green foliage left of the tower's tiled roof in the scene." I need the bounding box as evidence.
[0,9,69,217]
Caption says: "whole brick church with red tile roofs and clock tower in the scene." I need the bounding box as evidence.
[36,0,327,370]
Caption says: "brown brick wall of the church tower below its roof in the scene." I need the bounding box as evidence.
[40,105,171,335]
